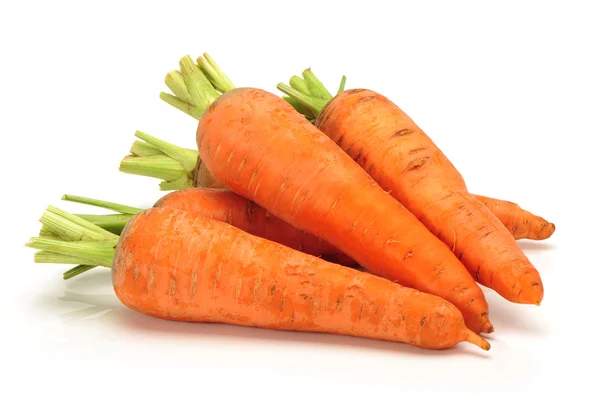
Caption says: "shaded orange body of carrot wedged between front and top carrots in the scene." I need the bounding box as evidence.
[154,187,355,266]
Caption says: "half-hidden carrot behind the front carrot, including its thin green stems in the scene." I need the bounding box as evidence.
[55,188,356,266]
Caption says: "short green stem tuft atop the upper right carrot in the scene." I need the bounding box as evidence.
[277,68,346,121]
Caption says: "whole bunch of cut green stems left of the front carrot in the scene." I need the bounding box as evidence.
[26,195,143,280]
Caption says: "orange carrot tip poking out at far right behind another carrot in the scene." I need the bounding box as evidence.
[475,195,555,240]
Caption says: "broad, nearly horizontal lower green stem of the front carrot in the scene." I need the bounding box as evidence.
[26,237,118,268]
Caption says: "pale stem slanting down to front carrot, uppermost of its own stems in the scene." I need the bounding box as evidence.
[40,206,118,240]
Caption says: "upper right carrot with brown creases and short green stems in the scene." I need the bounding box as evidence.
[278,70,544,305]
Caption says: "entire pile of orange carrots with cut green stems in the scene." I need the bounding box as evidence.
[27,54,555,350]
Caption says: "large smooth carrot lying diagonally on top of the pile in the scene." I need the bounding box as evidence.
[159,57,493,332]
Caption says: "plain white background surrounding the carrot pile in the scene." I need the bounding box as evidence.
[0,0,600,401]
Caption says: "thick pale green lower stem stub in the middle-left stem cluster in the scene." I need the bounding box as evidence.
[119,155,186,181]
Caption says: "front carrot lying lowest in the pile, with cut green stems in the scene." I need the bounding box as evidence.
[27,203,490,350]
